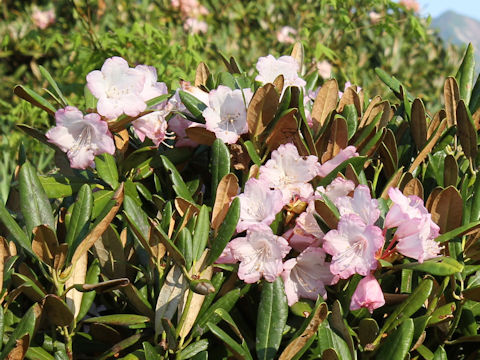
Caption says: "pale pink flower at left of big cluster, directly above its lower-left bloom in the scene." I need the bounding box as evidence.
[237,178,283,232]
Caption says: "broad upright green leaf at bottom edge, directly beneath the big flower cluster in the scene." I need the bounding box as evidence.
[255,277,288,360]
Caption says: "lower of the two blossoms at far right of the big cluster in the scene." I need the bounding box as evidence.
[395,214,440,263]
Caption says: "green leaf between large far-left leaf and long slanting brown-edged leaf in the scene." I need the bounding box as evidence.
[65,184,93,257]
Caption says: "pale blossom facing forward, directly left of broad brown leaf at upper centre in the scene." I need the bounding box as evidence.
[202,85,253,144]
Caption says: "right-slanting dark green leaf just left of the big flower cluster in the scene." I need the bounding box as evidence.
[206,197,240,266]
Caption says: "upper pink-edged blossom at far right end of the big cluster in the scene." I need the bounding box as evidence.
[384,187,428,229]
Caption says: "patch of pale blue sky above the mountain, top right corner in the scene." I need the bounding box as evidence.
[417,0,480,20]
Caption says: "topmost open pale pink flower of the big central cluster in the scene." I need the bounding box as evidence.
[259,144,320,204]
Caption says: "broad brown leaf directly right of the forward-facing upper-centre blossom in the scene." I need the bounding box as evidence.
[247,83,280,137]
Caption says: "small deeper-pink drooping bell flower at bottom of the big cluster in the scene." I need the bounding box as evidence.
[350,274,385,313]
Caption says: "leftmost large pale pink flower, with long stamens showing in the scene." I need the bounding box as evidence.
[46,106,115,169]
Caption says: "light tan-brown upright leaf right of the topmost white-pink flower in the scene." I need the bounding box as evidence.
[312,79,338,133]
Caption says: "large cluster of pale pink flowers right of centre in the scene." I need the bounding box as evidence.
[219,144,440,312]
